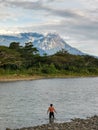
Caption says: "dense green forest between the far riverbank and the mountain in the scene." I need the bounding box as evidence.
[0,42,98,76]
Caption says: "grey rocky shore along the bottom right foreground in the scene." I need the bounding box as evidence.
[6,115,98,130]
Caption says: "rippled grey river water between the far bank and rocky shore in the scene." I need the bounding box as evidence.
[0,78,98,130]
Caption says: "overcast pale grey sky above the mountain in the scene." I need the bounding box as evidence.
[0,0,98,56]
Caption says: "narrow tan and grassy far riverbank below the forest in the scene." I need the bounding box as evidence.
[0,75,98,82]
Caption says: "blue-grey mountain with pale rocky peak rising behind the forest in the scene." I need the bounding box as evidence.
[0,33,84,55]
